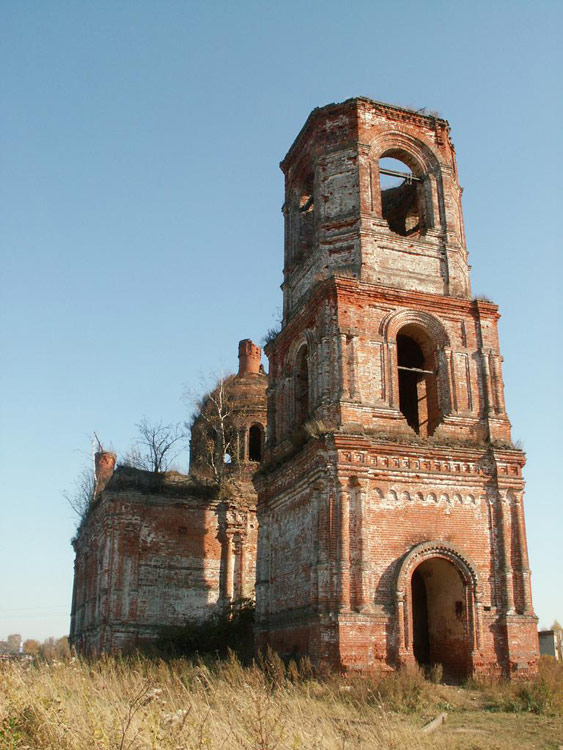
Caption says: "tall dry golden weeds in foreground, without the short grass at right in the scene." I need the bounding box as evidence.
[0,654,560,750]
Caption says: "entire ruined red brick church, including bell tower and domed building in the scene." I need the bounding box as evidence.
[71,98,538,678]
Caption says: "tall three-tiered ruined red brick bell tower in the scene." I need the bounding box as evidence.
[255,98,538,677]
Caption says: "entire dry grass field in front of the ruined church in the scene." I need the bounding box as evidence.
[0,655,563,750]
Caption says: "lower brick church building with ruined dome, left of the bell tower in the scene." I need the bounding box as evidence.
[70,339,267,652]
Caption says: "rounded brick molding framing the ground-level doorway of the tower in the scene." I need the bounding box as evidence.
[395,541,482,670]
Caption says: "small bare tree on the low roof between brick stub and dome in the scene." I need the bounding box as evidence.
[124,417,188,473]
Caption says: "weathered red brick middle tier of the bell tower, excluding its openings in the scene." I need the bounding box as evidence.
[268,277,510,449]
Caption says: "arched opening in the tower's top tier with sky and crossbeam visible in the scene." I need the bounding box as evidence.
[379,156,426,237]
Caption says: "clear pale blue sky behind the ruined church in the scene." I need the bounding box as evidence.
[0,0,563,639]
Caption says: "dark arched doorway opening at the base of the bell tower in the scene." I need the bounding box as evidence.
[411,557,471,679]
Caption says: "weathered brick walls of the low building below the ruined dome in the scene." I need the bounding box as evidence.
[71,470,257,652]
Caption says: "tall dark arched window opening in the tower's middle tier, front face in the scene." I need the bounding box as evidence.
[397,326,442,437]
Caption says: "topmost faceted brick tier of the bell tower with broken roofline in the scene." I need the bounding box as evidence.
[280,97,471,322]
